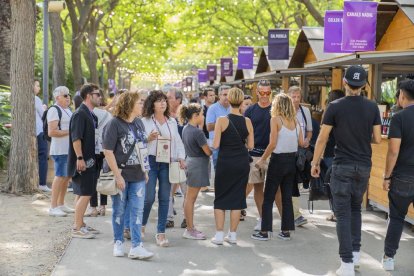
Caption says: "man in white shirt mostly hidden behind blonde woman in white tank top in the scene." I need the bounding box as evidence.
[288,86,313,226]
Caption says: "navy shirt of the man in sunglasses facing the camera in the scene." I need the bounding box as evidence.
[244,104,272,157]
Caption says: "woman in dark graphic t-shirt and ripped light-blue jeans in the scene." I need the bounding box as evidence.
[103,92,154,259]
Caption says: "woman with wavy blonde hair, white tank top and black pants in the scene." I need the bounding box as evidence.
[251,93,303,241]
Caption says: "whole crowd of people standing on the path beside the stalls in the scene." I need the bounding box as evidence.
[34,66,414,275]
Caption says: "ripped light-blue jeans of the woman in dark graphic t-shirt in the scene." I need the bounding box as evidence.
[112,181,145,247]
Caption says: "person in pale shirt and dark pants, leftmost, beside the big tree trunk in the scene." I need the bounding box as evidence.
[33,80,52,192]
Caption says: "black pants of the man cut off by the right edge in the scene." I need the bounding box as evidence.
[384,175,414,258]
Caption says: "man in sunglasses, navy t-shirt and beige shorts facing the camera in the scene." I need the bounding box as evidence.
[244,80,272,230]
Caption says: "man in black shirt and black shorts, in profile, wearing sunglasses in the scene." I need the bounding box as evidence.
[68,84,101,239]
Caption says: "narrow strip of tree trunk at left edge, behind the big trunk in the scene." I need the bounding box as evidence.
[0,0,11,86]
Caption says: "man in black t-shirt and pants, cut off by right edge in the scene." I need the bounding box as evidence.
[382,80,414,271]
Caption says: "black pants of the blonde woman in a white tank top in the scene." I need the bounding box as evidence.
[262,153,296,232]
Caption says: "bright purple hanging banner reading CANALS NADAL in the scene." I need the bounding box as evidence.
[342,1,378,51]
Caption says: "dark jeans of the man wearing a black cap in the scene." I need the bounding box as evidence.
[331,164,371,263]
